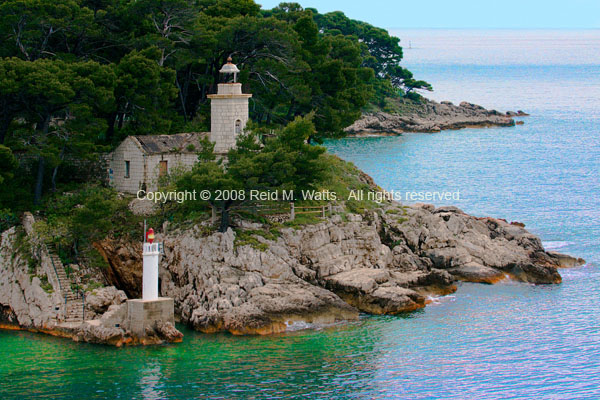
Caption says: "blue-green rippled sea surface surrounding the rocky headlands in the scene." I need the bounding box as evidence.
[0,30,600,399]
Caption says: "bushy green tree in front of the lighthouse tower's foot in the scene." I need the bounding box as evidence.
[176,114,325,232]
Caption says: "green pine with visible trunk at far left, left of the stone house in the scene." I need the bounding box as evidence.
[4,58,114,204]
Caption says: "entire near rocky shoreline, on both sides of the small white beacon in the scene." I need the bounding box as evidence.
[0,198,584,346]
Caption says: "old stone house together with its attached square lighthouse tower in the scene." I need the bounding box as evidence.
[107,58,252,193]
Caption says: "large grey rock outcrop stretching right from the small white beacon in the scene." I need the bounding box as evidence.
[97,203,581,334]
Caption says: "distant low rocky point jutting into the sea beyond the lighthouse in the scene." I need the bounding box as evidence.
[346,99,528,136]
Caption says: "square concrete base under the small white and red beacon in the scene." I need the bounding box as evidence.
[127,297,175,338]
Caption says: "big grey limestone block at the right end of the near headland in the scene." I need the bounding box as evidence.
[383,205,561,283]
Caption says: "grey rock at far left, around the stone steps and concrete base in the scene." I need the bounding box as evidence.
[0,223,182,346]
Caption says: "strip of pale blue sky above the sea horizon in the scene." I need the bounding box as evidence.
[255,0,600,29]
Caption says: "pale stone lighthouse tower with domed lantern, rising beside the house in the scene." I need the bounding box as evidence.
[208,57,252,154]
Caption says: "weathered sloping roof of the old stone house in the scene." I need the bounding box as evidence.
[130,132,209,155]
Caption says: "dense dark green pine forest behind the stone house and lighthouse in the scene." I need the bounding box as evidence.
[0,0,431,207]
